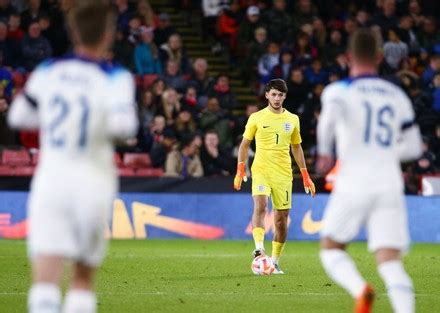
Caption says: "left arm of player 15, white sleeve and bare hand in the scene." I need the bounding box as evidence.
[316,87,341,174]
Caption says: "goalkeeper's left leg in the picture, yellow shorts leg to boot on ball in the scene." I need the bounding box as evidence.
[252,175,271,258]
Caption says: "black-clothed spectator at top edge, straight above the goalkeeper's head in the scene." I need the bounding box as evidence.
[262,0,292,42]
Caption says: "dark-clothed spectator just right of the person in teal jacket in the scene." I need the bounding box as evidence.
[159,33,191,74]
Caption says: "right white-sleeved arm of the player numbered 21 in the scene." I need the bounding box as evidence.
[106,73,139,141]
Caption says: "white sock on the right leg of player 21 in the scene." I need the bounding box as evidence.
[63,289,96,313]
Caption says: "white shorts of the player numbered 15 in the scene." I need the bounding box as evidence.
[321,191,410,252]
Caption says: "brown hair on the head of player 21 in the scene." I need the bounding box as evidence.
[67,0,116,46]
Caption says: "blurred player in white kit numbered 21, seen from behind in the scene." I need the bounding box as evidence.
[8,0,138,313]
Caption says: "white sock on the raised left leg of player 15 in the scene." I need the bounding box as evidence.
[320,249,366,299]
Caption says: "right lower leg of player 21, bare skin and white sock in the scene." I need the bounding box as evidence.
[63,263,96,313]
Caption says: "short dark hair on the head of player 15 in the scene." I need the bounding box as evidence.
[348,28,379,63]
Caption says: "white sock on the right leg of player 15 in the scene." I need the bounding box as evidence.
[378,260,415,313]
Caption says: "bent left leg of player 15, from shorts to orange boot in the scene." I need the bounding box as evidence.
[320,192,373,312]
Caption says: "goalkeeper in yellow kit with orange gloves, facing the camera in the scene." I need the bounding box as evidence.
[234,79,315,274]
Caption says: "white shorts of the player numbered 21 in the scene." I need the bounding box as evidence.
[27,171,116,267]
